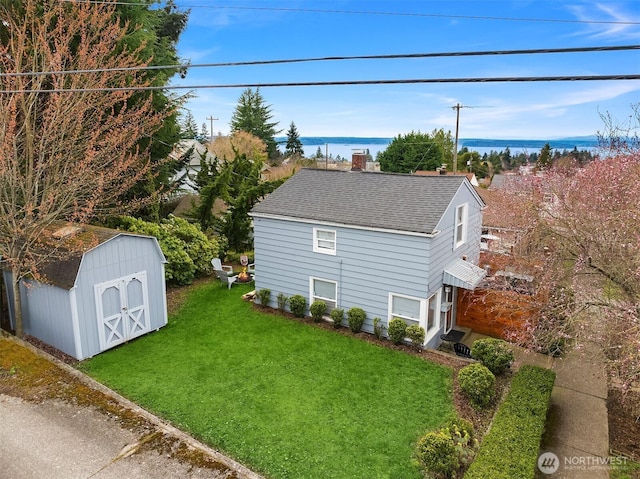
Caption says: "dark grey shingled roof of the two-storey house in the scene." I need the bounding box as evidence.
[252,169,476,234]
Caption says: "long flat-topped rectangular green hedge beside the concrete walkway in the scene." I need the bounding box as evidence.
[464,365,556,479]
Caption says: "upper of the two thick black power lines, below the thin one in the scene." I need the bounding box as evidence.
[0,45,640,78]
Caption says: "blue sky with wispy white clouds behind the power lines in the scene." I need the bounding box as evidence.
[174,0,640,139]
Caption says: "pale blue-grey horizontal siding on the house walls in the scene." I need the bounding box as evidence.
[253,176,482,346]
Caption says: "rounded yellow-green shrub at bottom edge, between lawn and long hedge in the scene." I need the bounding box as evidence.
[416,430,460,479]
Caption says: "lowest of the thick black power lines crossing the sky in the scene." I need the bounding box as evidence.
[0,74,640,94]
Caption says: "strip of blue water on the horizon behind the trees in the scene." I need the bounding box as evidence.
[276,136,598,161]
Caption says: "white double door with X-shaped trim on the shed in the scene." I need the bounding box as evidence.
[94,271,149,351]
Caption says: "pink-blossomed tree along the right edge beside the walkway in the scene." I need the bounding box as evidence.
[488,124,640,398]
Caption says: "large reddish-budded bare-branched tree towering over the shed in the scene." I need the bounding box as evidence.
[0,0,173,336]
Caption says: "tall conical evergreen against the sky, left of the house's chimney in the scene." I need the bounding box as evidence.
[230,88,282,161]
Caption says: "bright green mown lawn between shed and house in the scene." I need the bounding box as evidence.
[82,280,454,479]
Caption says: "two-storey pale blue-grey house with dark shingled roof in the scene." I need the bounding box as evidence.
[251,169,485,347]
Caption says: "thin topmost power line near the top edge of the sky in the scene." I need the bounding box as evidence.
[62,0,640,25]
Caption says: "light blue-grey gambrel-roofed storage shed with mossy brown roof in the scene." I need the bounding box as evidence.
[3,225,167,359]
